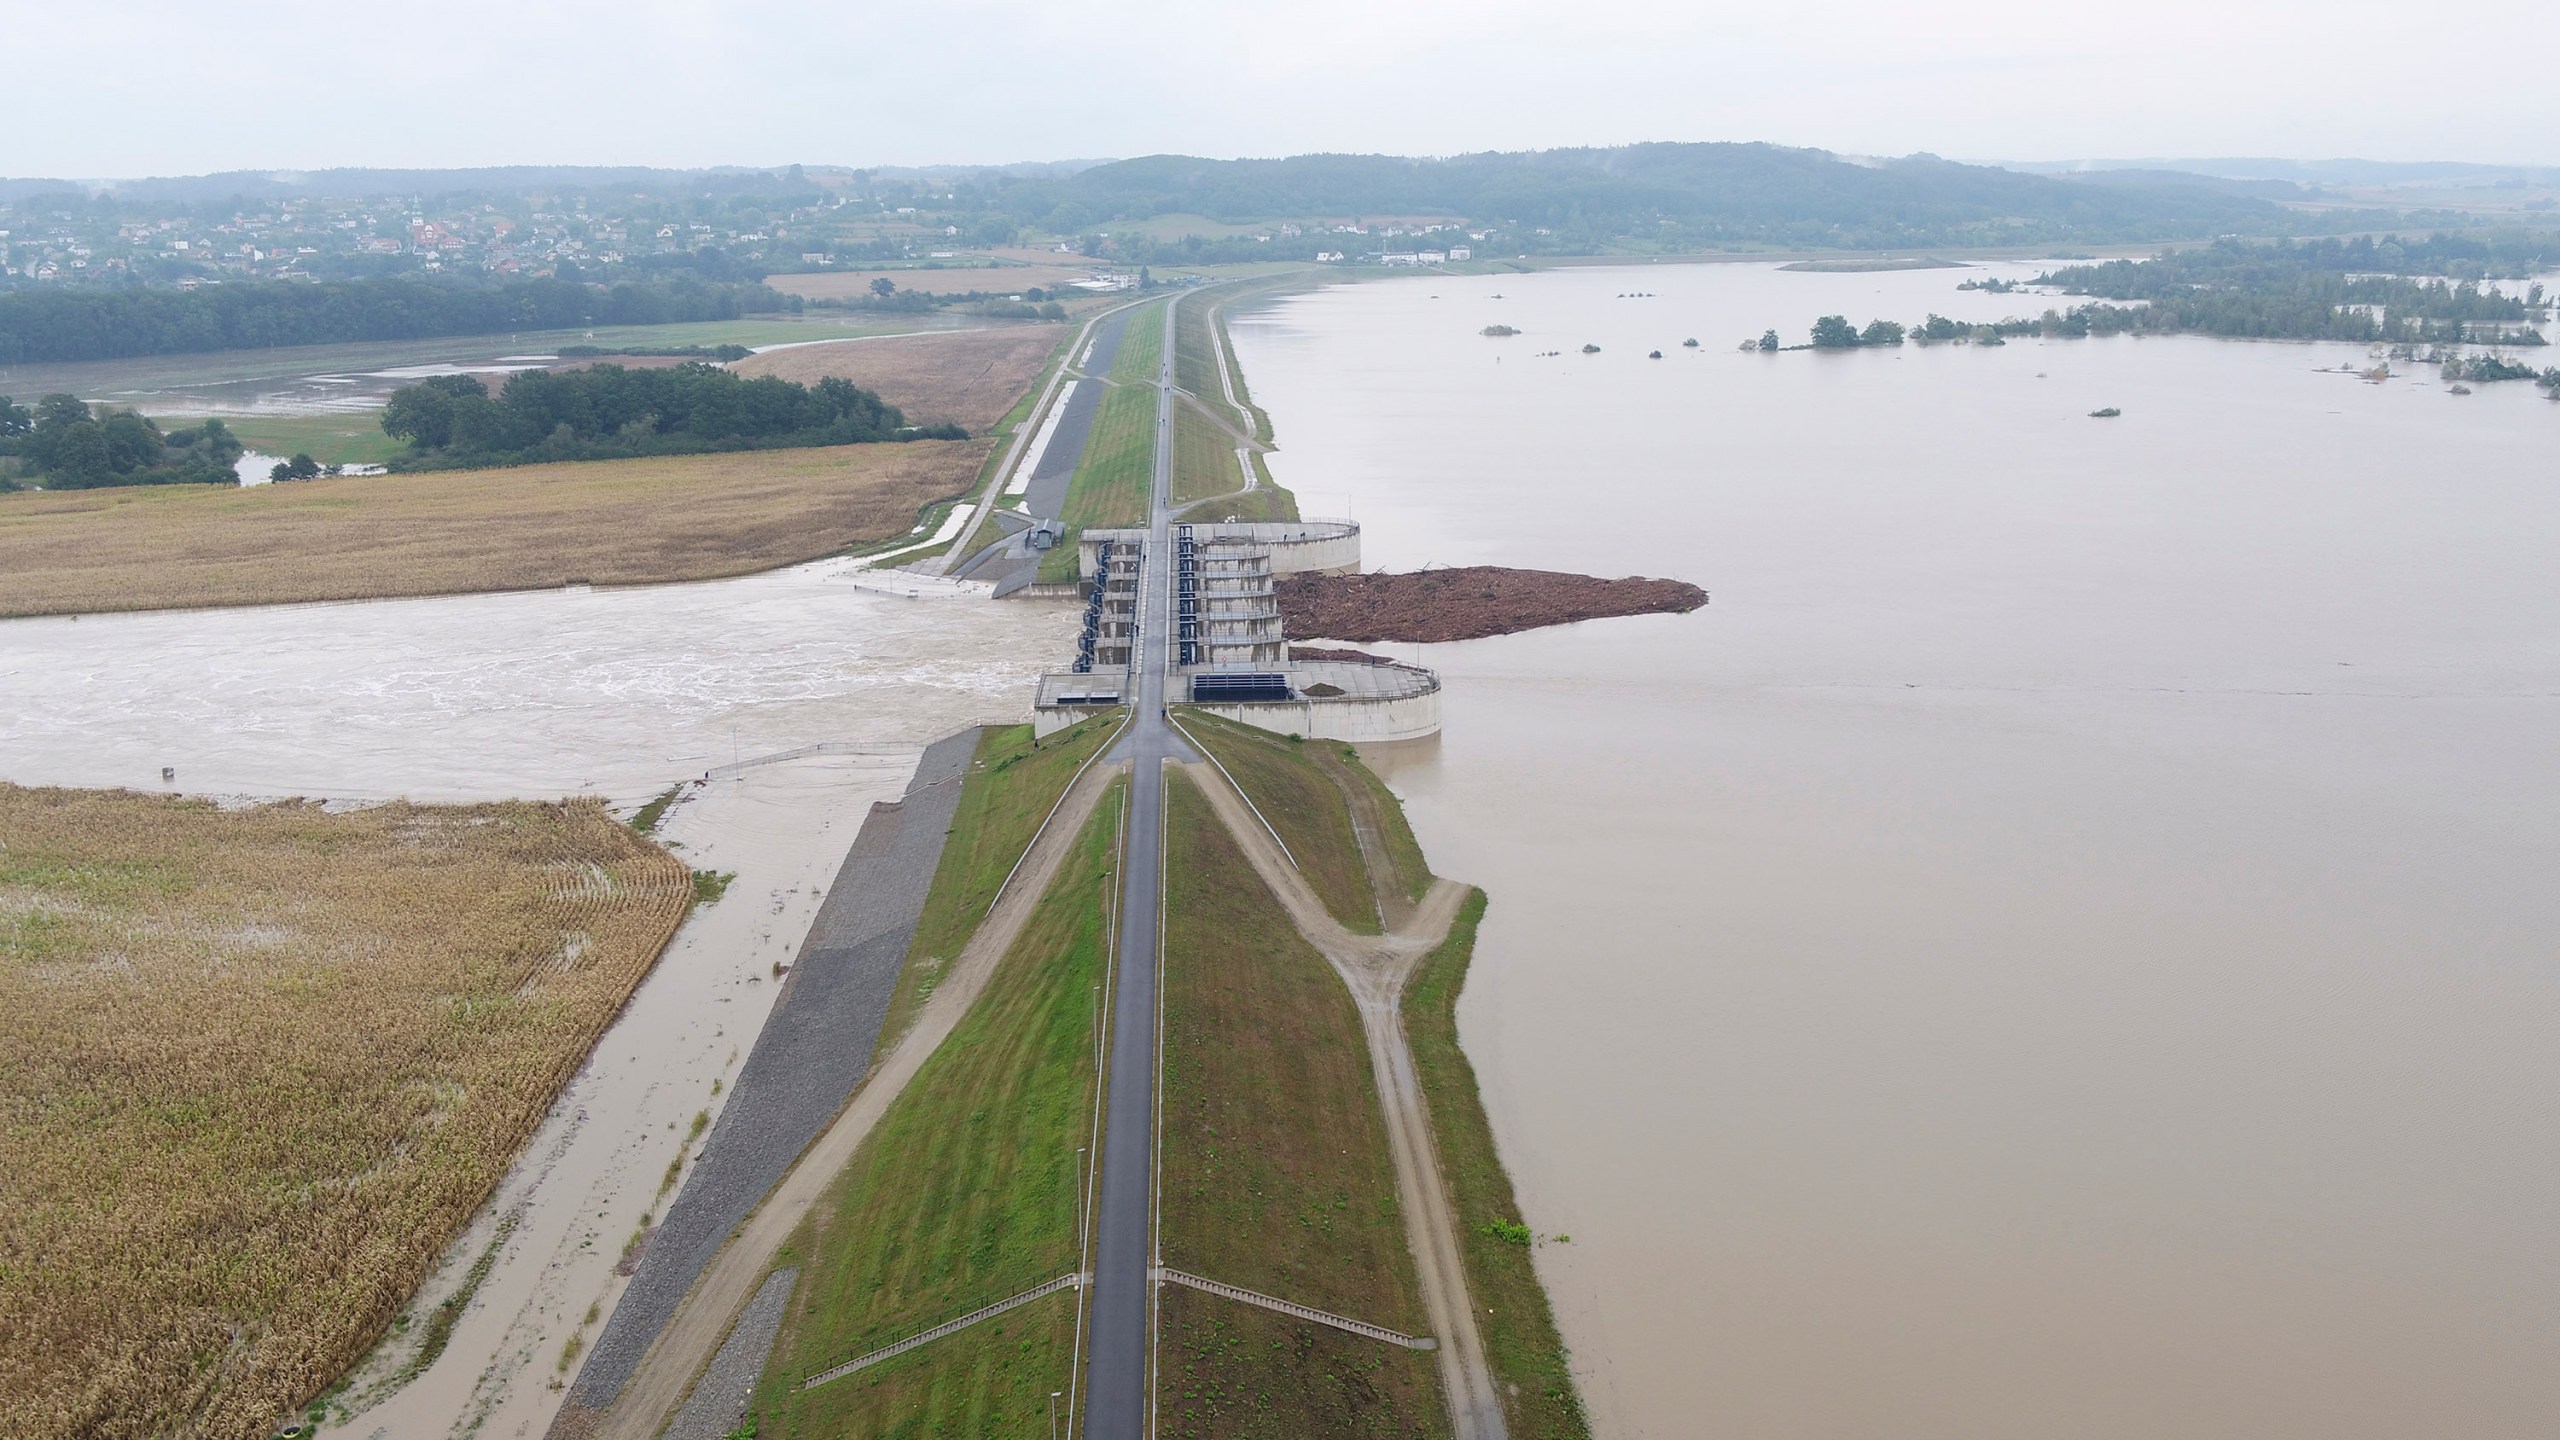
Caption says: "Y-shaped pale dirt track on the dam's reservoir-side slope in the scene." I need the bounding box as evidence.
[1183,764,1508,1440]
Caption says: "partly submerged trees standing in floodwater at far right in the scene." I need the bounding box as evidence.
[2035,238,2542,346]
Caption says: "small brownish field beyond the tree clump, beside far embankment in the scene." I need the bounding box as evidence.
[730,325,1075,436]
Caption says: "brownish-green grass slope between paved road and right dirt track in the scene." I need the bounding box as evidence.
[1160,774,1444,1435]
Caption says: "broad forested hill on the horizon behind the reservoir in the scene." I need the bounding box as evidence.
[998,143,2324,251]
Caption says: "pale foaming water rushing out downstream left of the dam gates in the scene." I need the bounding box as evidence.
[0,566,1070,799]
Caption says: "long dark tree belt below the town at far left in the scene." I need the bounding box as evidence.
[0,277,801,364]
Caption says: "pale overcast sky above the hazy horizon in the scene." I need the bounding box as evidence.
[0,0,2560,179]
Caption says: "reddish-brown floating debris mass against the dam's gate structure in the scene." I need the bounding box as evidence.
[1277,566,1708,643]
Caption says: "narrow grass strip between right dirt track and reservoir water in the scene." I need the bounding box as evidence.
[1405,892,1590,1440]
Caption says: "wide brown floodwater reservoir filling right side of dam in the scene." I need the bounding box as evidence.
[1236,264,2560,1440]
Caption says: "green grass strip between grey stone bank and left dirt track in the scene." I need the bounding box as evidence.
[873,712,1119,1058]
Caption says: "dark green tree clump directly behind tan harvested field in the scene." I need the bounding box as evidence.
[381,364,968,469]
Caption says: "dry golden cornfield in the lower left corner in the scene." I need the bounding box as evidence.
[0,784,691,1440]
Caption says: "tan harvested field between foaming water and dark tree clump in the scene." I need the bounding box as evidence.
[0,441,988,615]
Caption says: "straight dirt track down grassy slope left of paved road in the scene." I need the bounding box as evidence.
[565,753,1119,1440]
